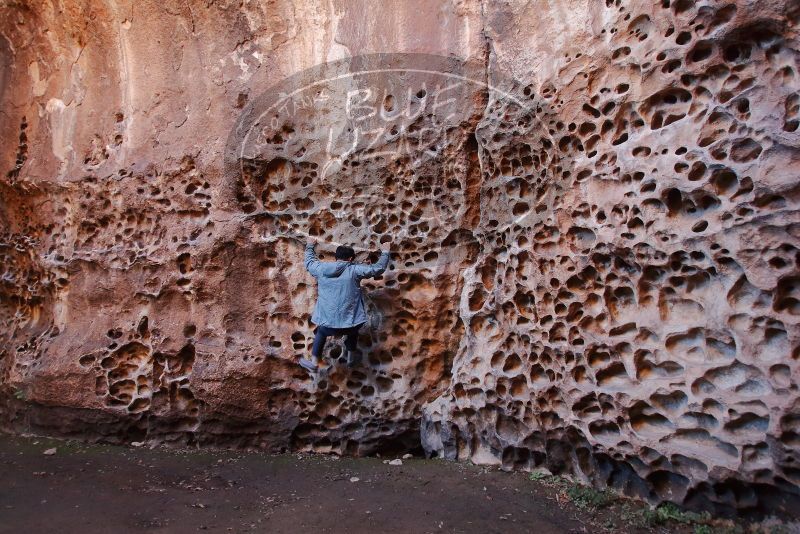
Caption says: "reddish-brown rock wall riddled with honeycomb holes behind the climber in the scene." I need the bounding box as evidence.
[0,0,800,511]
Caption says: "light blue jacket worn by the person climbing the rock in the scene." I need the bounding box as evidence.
[305,244,389,328]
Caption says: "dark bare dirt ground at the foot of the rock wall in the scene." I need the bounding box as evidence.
[0,434,788,534]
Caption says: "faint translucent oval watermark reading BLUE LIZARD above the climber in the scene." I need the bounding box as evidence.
[225,54,552,258]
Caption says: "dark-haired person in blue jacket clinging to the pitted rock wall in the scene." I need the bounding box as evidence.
[300,238,390,372]
